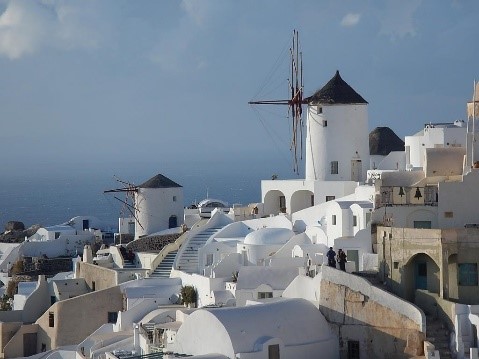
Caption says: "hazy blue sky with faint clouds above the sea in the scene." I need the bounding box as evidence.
[0,0,479,179]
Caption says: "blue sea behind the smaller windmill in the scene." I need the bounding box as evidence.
[0,163,294,233]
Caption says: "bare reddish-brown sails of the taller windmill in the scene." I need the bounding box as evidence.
[248,30,307,174]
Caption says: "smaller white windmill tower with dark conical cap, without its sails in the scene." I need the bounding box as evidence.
[135,174,184,238]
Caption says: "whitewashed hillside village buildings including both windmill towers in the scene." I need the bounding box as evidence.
[0,72,479,359]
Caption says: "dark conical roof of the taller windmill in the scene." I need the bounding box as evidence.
[304,71,368,105]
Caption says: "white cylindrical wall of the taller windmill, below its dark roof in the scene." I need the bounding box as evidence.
[305,104,369,181]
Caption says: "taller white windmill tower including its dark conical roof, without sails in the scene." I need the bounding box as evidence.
[305,71,369,182]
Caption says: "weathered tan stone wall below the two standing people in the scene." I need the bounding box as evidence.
[319,280,424,358]
